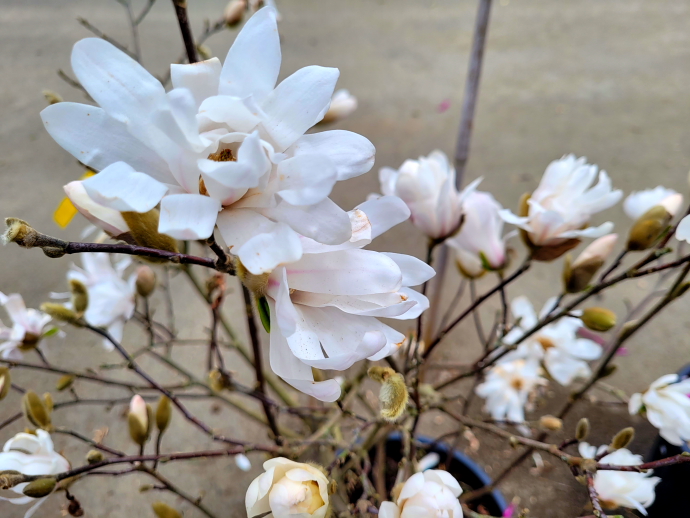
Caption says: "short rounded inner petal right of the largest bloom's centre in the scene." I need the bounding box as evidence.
[278,155,338,205]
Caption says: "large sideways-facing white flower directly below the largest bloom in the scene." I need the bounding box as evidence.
[266,196,434,401]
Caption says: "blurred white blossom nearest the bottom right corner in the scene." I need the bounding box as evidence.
[578,442,661,516]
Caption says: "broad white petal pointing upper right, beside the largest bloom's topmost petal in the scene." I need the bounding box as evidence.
[262,66,340,152]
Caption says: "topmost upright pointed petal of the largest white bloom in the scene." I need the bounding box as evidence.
[219,7,281,102]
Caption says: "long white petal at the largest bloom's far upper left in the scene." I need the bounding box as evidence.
[72,38,166,123]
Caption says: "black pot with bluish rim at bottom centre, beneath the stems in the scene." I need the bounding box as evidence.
[360,434,507,516]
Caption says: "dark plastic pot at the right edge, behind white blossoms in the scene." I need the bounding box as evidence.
[647,365,690,518]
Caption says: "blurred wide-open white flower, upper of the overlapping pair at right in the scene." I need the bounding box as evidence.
[499,297,602,385]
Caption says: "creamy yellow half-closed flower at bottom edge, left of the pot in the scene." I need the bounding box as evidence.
[245,457,328,518]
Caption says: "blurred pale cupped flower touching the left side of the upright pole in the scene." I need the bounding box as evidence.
[379,150,481,239]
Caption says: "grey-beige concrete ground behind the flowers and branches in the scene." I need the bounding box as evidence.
[0,0,690,518]
